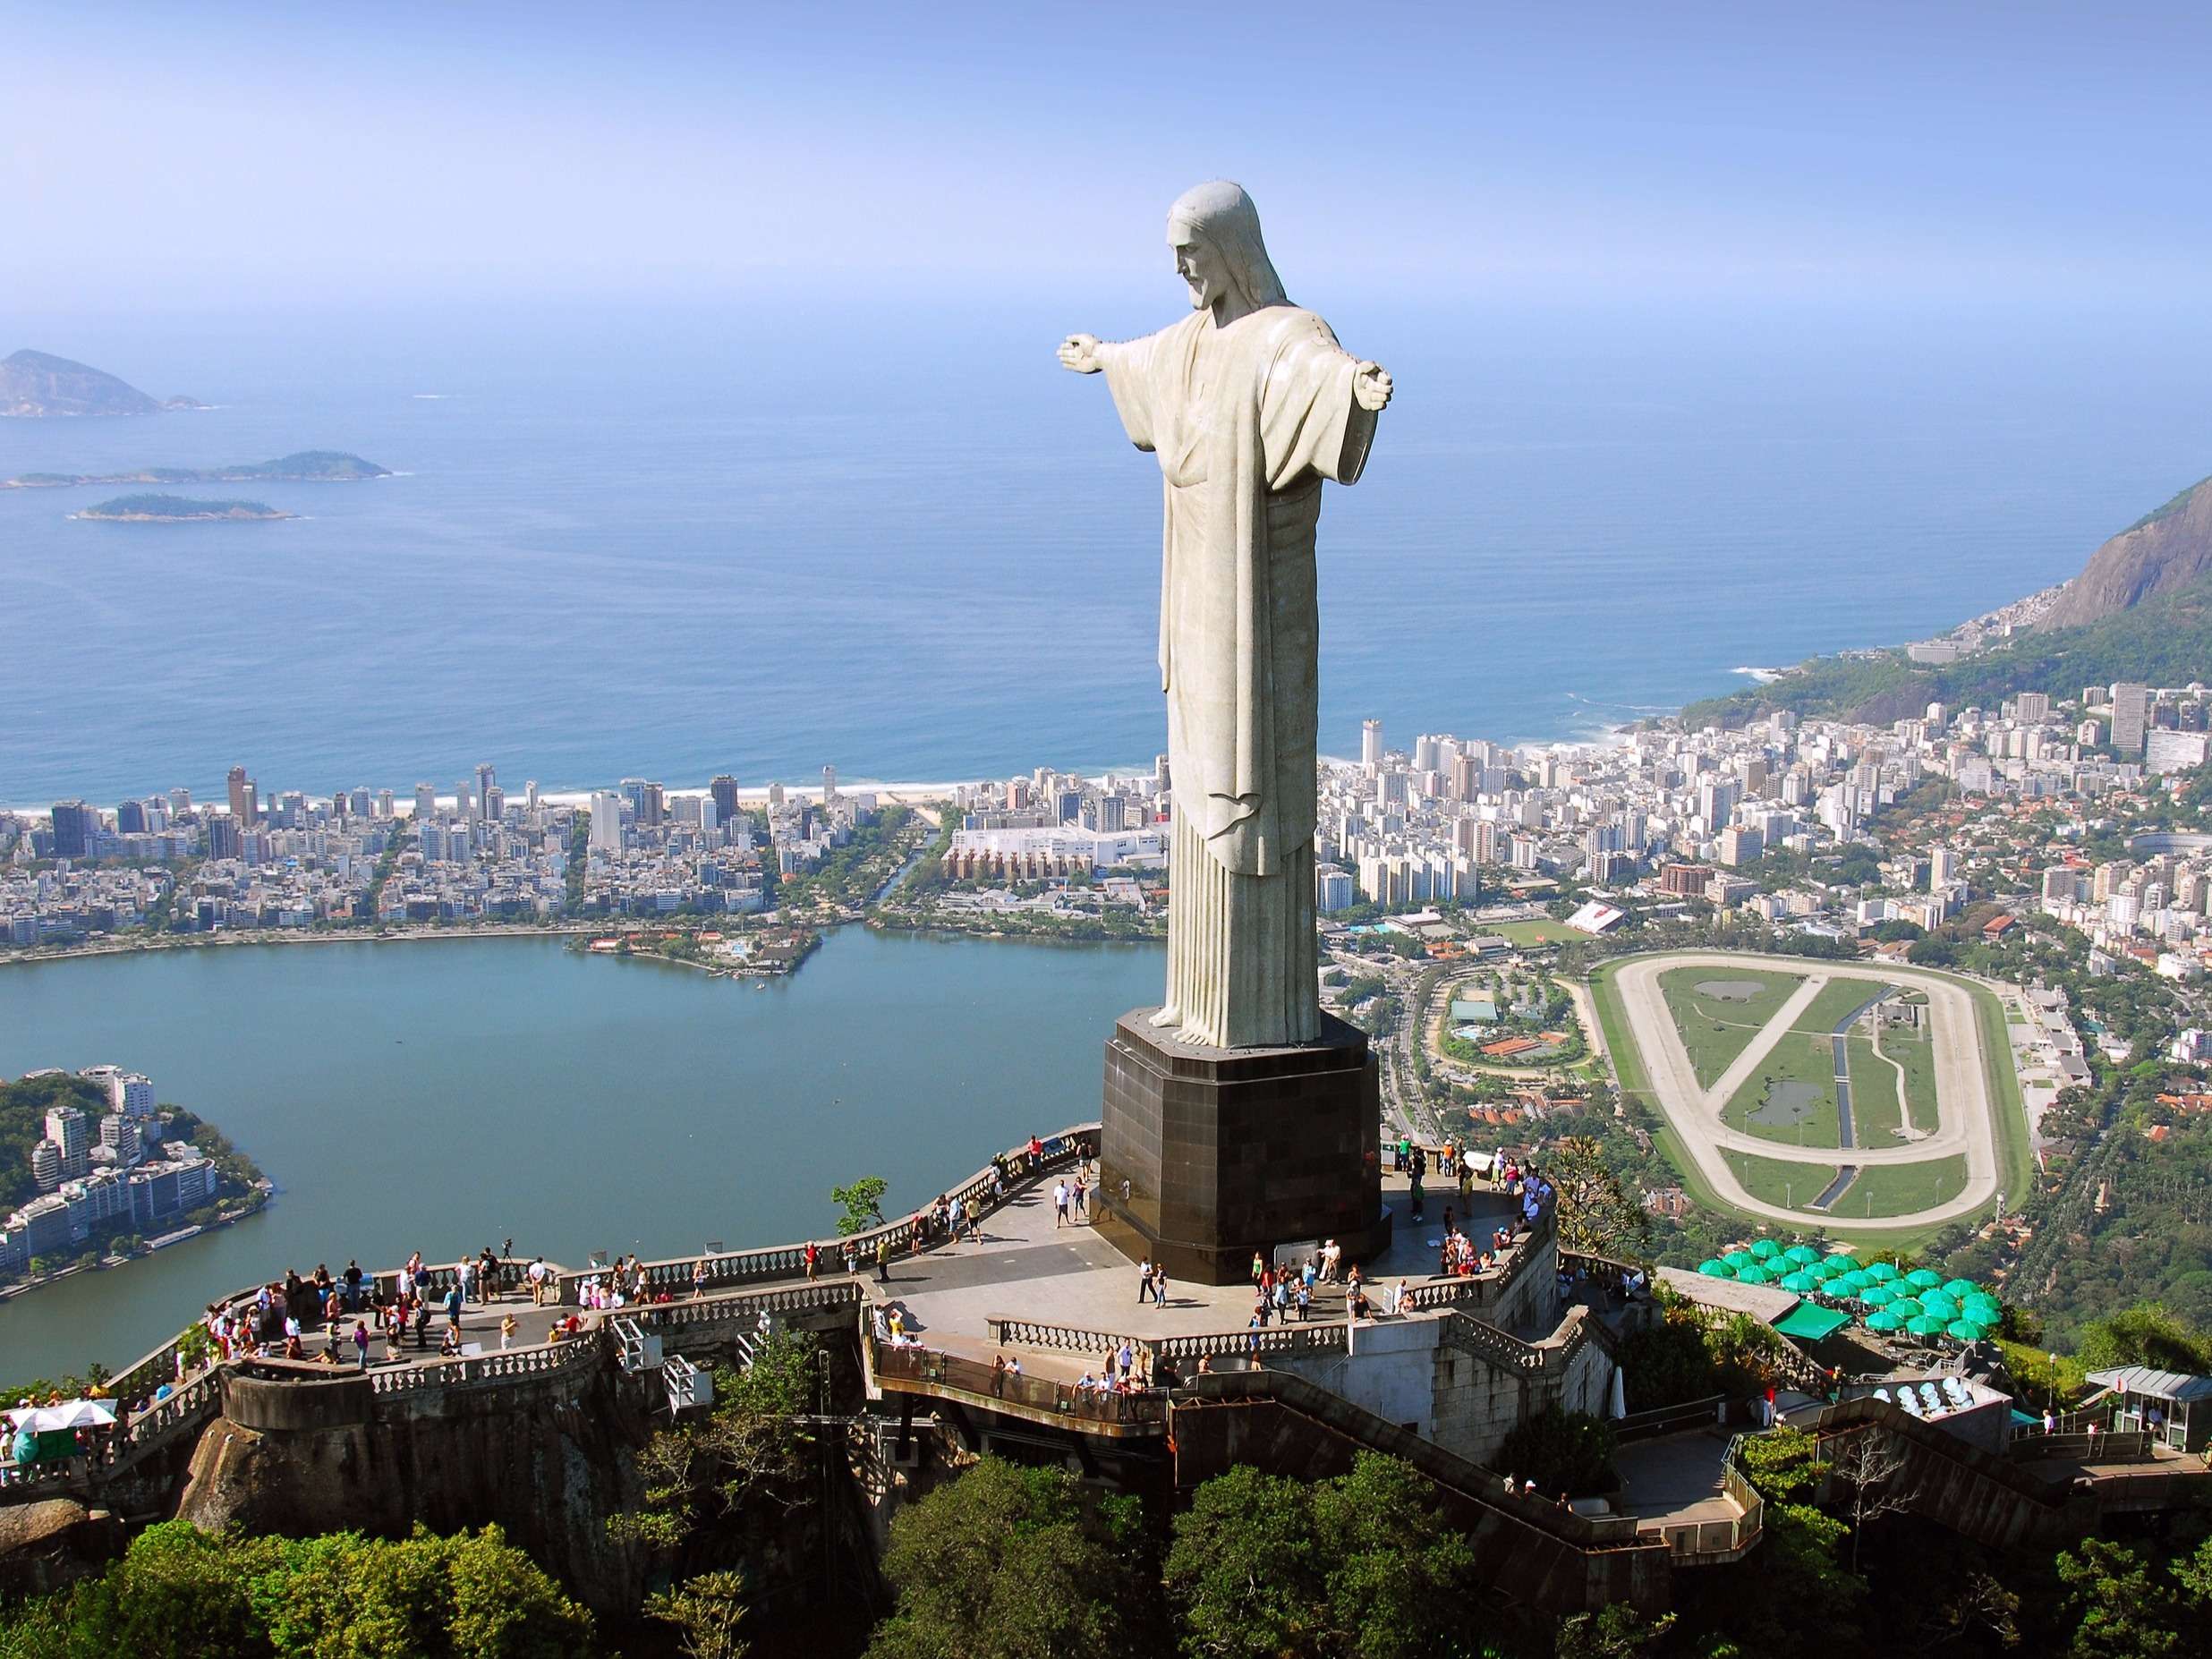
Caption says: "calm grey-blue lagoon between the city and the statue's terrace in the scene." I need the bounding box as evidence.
[0,927,1161,1384]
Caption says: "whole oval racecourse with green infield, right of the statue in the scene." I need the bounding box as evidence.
[1593,951,2029,1234]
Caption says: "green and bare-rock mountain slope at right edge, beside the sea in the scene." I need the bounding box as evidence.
[1681,478,2212,730]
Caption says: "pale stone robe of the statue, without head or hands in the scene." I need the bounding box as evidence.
[1102,305,1376,1049]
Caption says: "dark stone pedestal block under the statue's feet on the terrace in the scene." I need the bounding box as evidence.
[1095,1008,1389,1285]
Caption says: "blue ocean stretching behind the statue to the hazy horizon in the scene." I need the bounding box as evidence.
[0,296,2212,803]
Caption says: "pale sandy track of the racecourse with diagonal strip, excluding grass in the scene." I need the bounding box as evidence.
[1612,951,2011,1232]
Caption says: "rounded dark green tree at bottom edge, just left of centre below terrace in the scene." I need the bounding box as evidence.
[867,1458,1161,1659]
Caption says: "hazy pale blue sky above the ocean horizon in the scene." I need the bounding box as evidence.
[0,0,2212,314]
